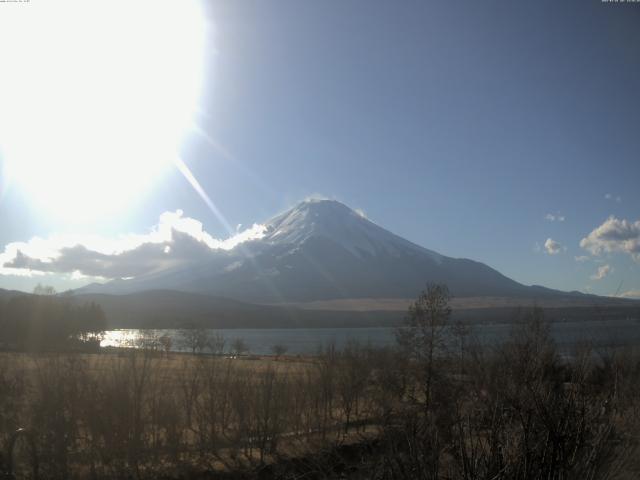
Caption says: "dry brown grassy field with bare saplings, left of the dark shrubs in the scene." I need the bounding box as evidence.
[0,350,392,478]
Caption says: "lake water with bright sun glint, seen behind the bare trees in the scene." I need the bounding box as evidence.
[101,319,640,355]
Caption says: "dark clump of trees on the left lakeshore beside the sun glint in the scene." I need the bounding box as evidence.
[0,285,107,350]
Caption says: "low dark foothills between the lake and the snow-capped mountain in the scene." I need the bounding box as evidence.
[0,289,640,329]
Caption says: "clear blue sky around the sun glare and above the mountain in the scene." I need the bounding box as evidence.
[0,0,640,295]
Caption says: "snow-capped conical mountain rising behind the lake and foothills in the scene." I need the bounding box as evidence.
[76,200,560,303]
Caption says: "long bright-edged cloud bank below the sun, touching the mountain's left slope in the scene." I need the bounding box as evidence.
[0,210,265,279]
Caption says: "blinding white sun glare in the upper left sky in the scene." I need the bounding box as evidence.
[0,0,204,220]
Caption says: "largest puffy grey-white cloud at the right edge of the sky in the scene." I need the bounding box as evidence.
[580,215,640,261]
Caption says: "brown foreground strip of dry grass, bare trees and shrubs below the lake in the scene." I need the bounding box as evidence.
[0,286,640,480]
